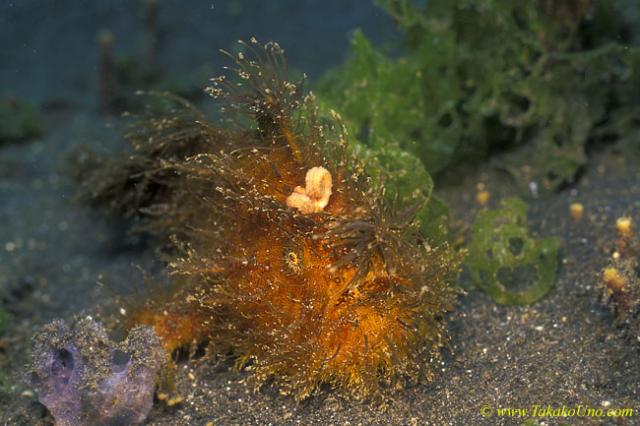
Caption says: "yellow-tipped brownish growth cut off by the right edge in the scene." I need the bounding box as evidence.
[598,217,640,344]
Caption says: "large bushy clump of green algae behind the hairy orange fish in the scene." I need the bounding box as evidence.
[320,0,640,189]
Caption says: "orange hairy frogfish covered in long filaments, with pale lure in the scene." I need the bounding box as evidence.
[80,39,459,400]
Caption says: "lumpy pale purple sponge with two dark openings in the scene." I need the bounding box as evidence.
[26,317,166,426]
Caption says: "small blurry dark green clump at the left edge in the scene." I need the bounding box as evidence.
[0,97,44,143]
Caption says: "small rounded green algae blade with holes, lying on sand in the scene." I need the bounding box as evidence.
[465,198,558,305]
